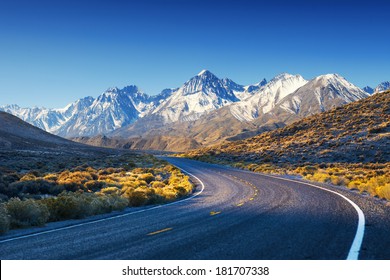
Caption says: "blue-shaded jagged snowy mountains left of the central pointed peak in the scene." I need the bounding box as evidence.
[0,86,174,137]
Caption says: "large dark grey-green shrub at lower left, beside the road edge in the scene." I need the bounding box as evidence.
[5,198,49,228]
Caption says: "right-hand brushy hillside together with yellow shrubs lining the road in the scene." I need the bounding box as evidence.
[182,91,390,200]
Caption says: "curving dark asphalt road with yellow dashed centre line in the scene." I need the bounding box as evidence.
[0,158,390,259]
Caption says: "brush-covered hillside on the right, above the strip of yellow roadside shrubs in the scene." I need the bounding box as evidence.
[188,91,390,164]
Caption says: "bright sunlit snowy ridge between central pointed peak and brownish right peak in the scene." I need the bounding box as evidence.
[230,73,307,121]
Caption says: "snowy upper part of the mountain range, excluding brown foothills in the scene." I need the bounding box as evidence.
[0,70,374,137]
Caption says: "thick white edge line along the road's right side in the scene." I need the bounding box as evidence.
[240,170,365,260]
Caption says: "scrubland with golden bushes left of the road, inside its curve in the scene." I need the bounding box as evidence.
[0,153,193,233]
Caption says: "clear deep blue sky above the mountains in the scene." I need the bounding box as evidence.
[0,0,390,108]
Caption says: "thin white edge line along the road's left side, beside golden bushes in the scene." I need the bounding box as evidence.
[0,168,205,244]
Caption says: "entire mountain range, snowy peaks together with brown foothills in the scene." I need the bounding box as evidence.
[0,70,390,151]
